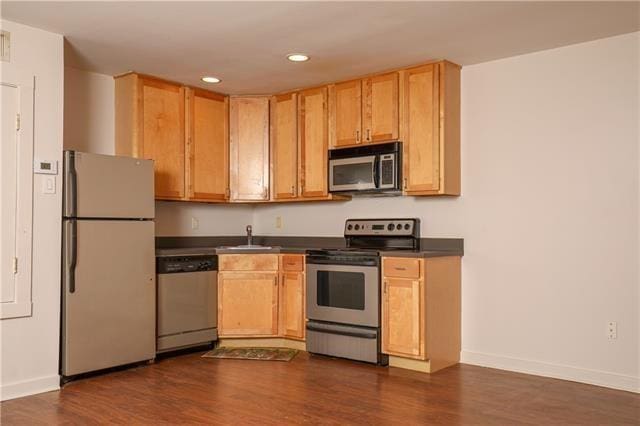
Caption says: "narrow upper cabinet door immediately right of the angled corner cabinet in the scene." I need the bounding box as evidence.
[271,93,298,200]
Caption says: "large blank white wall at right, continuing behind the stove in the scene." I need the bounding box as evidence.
[254,33,640,390]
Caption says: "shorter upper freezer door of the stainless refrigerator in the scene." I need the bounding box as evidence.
[64,151,155,219]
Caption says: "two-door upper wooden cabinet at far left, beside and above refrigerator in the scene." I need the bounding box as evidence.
[115,73,228,201]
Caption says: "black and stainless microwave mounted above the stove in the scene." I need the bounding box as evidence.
[329,142,402,195]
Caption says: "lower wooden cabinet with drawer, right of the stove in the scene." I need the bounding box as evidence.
[382,256,461,372]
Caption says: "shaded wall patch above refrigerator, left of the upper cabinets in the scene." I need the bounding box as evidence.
[64,67,115,155]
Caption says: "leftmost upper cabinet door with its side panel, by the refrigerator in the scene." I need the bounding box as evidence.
[115,73,185,200]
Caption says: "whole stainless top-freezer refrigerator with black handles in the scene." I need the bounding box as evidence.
[60,151,156,377]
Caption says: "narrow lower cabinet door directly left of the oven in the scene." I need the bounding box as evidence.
[280,272,305,339]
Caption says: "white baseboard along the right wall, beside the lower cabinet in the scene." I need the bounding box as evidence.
[460,351,640,393]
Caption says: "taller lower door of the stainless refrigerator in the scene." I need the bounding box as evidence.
[62,220,156,376]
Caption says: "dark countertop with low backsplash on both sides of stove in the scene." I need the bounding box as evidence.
[156,236,464,258]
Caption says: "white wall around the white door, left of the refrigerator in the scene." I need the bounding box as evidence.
[0,20,64,400]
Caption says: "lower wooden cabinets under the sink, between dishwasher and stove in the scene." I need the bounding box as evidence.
[218,254,306,340]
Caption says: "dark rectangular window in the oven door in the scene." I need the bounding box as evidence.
[317,271,365,311]
